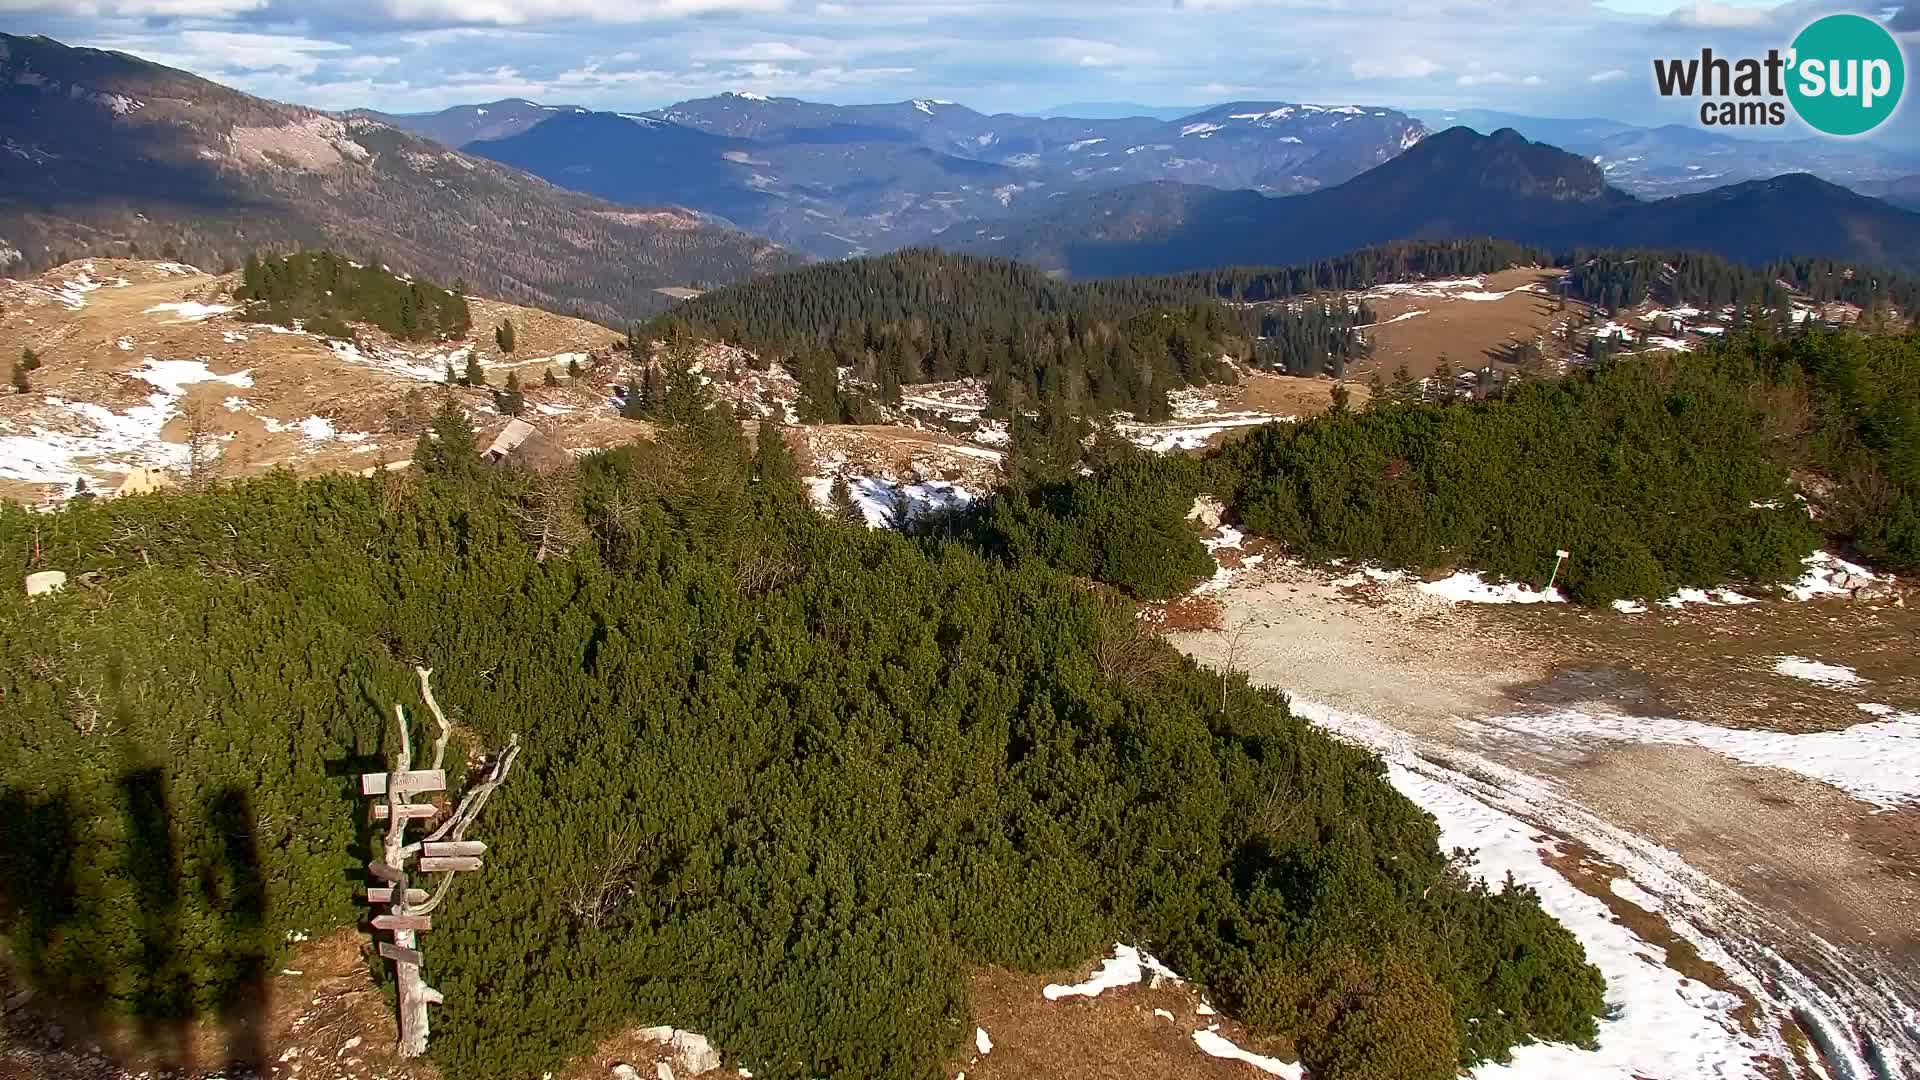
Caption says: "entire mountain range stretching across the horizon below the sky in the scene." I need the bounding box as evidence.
[11,37,1920,315]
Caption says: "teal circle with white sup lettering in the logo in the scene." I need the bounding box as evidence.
[1788,15,1907,135]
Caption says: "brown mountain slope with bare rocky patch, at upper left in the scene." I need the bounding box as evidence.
[0,35,797,323]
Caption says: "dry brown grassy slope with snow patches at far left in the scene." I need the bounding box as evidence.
[0,259,651,502]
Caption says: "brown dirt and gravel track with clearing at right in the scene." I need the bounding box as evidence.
[1171,567,1920,1078]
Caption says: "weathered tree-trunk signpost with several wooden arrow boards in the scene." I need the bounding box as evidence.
[361,667,520,1057]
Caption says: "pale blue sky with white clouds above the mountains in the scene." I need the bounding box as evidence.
[0,0,1920,146]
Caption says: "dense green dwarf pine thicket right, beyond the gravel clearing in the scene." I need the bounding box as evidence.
[941,327,1920,603]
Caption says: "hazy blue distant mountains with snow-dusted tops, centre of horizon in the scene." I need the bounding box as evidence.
[386,94,1427,258]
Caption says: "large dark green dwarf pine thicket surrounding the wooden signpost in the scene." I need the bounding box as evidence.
[0,399,1603,1080]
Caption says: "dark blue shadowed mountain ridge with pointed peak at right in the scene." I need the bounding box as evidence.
[935,127,1920,277]
